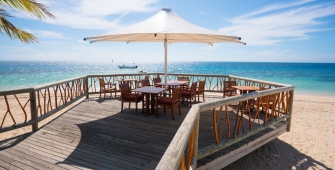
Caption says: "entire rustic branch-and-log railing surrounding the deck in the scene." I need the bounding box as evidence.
[0,73,294,169]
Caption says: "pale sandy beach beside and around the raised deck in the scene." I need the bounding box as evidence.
[0,94,335,170]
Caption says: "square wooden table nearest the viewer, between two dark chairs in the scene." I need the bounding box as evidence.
[132,87,165,117]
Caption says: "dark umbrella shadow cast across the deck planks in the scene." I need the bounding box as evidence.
[58,105,182,169]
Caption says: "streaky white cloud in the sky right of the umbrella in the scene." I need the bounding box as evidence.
[219,1,335,45]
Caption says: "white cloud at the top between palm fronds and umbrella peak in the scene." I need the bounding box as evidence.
[14,0,157,30]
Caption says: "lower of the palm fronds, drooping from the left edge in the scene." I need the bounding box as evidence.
[0,13,38,43]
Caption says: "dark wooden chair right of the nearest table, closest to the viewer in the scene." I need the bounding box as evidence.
[156,87,181,120]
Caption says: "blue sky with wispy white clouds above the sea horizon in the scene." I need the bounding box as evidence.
[0,0,335,63]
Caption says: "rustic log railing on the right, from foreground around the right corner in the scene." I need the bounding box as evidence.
[156,76,294,170]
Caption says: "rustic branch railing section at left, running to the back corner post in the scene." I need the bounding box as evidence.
[0,76,87,133]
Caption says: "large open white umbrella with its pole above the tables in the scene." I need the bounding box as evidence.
[84,8,245,87]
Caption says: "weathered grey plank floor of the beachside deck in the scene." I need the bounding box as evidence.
[0,96,285,170]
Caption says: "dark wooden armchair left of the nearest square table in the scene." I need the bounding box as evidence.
[119,83,144,113]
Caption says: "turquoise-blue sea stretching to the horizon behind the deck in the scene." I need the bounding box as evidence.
[0,61,335,96]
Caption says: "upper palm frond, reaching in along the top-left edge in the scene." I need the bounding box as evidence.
[0,0,56,19]
